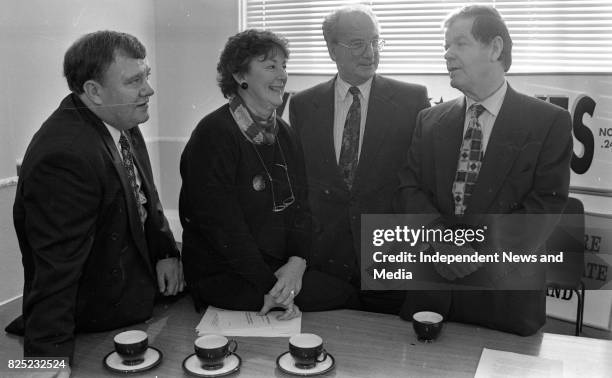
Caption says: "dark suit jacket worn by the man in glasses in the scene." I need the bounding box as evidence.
[289,75,429,281]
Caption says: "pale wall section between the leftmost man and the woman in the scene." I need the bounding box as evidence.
[154,0,238,230]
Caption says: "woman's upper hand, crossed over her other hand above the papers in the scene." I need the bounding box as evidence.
[268,256,306,308]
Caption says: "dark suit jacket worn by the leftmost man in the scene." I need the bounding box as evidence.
[13,94,178,358]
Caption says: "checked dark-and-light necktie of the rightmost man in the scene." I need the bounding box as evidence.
[453,104,485,215]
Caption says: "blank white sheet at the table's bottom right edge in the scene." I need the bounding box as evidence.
[474,348,563,378]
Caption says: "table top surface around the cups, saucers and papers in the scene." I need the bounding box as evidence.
[0,296,612,377]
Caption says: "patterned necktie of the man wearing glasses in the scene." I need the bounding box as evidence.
[338,87,361,189]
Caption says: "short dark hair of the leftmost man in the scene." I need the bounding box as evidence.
[64,30,147,94]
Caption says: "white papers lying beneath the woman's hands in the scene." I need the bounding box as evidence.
[196,306,302,337]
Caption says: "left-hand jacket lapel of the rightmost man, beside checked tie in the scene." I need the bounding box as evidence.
[434,97,465,214]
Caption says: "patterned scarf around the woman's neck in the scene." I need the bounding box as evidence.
[229,94,278,145]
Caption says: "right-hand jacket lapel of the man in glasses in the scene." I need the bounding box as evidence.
[353,76,396,187]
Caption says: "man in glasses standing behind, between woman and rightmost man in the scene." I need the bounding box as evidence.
[289,6,429,314]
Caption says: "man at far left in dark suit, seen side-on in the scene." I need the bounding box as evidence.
[13,31,183,360]
